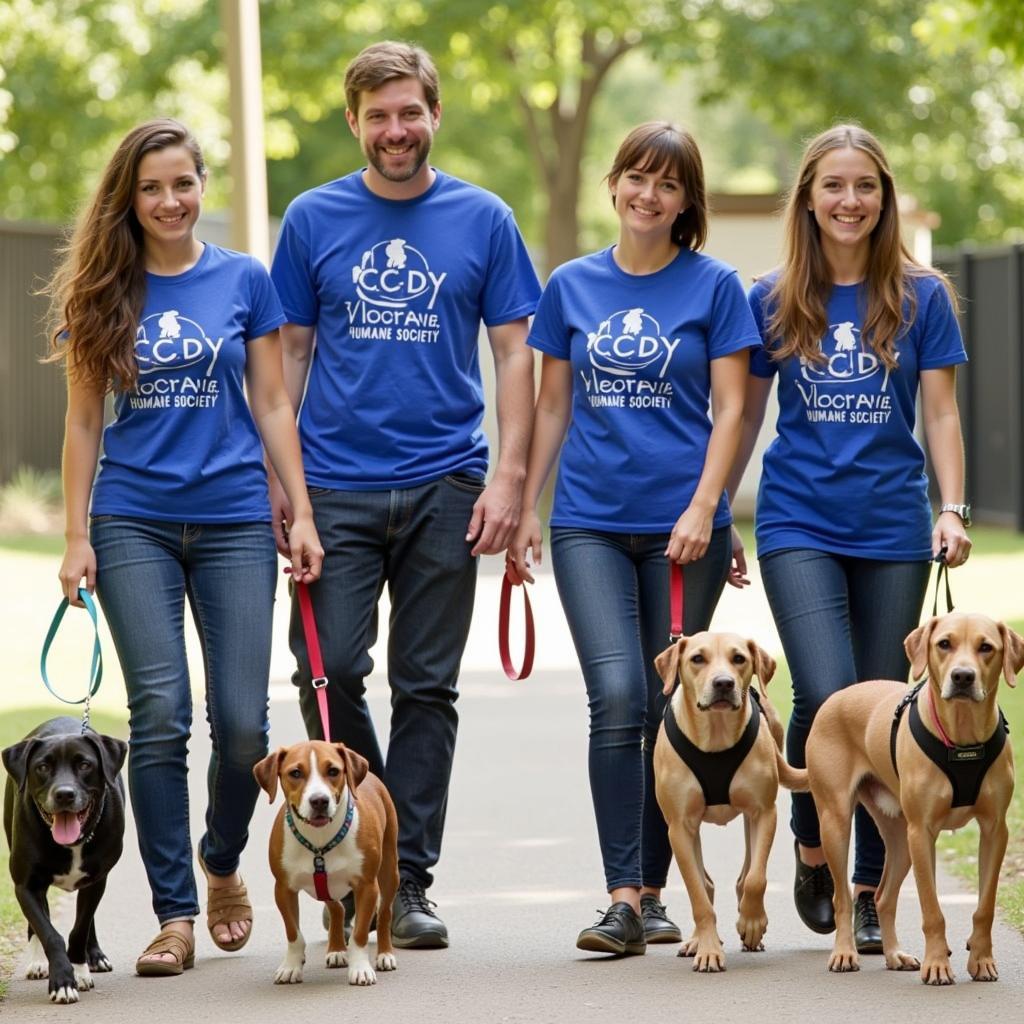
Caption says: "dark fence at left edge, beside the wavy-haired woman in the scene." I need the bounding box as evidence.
[0,221,66,483]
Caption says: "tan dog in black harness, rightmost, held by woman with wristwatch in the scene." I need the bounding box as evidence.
[807,612,1024,985]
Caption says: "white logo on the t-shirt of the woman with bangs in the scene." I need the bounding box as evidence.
[580,306,680,409]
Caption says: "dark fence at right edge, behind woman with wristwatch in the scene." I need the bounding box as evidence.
[935,245,1024,530]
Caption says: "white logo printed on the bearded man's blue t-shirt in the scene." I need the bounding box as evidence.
[345,239,447,344]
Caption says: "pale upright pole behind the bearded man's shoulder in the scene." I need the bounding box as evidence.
[220,0,270,263]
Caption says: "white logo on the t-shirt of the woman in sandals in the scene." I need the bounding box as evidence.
[128,309,224,409]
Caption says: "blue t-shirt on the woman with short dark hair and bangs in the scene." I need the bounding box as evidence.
[529,249,761,534]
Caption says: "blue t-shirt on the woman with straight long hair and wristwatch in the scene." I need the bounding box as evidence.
[750,276,967,561]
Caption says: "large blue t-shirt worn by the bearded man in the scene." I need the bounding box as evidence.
[271,171,541,490]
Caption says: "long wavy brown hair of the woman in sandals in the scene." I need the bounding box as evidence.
[45,118,206,393]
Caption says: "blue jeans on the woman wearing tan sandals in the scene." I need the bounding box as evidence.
[90,516,278,924]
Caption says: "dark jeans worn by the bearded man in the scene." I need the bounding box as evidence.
[290,474,483,886]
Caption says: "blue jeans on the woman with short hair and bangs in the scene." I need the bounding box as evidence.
[551,526,732,892]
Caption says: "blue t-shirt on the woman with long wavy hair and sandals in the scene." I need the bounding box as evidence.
[91,243,285,522]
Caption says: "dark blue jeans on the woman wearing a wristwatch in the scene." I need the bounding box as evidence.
[760,548,931,886]
